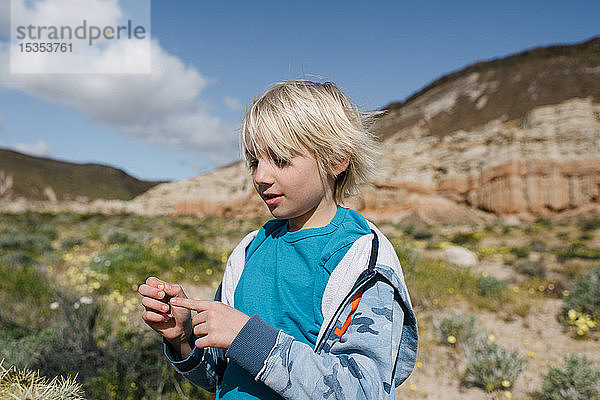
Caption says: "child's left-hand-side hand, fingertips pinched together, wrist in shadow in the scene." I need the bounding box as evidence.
[138,277,193,358]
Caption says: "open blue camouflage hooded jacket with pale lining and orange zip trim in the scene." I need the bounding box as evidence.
[165,222,418,399]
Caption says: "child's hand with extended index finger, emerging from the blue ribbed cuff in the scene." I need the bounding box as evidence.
[169,297,250,349]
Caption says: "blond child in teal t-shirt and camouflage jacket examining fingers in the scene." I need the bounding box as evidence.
[139,81,418,399]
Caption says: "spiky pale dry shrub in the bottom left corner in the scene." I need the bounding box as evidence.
[0,362,84,400]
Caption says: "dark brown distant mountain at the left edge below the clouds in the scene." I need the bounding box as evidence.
[0,149,163,202]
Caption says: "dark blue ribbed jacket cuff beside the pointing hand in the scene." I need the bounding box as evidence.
[225,314,279,377]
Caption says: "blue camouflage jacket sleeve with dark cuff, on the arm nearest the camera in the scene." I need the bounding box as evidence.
[226,274,404,400]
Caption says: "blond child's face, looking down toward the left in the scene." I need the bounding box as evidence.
[251,149,337,230]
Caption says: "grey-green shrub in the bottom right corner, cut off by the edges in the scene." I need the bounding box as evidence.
[533,354,600,400]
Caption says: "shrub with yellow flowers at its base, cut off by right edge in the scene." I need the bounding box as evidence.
[562,266,600,336]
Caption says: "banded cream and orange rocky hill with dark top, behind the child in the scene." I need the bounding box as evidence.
[5,38,600,224]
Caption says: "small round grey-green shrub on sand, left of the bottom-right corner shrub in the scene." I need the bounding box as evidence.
[463,339,526,392]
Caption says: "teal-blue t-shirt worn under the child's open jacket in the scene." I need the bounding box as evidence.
[216,206,371,400]
